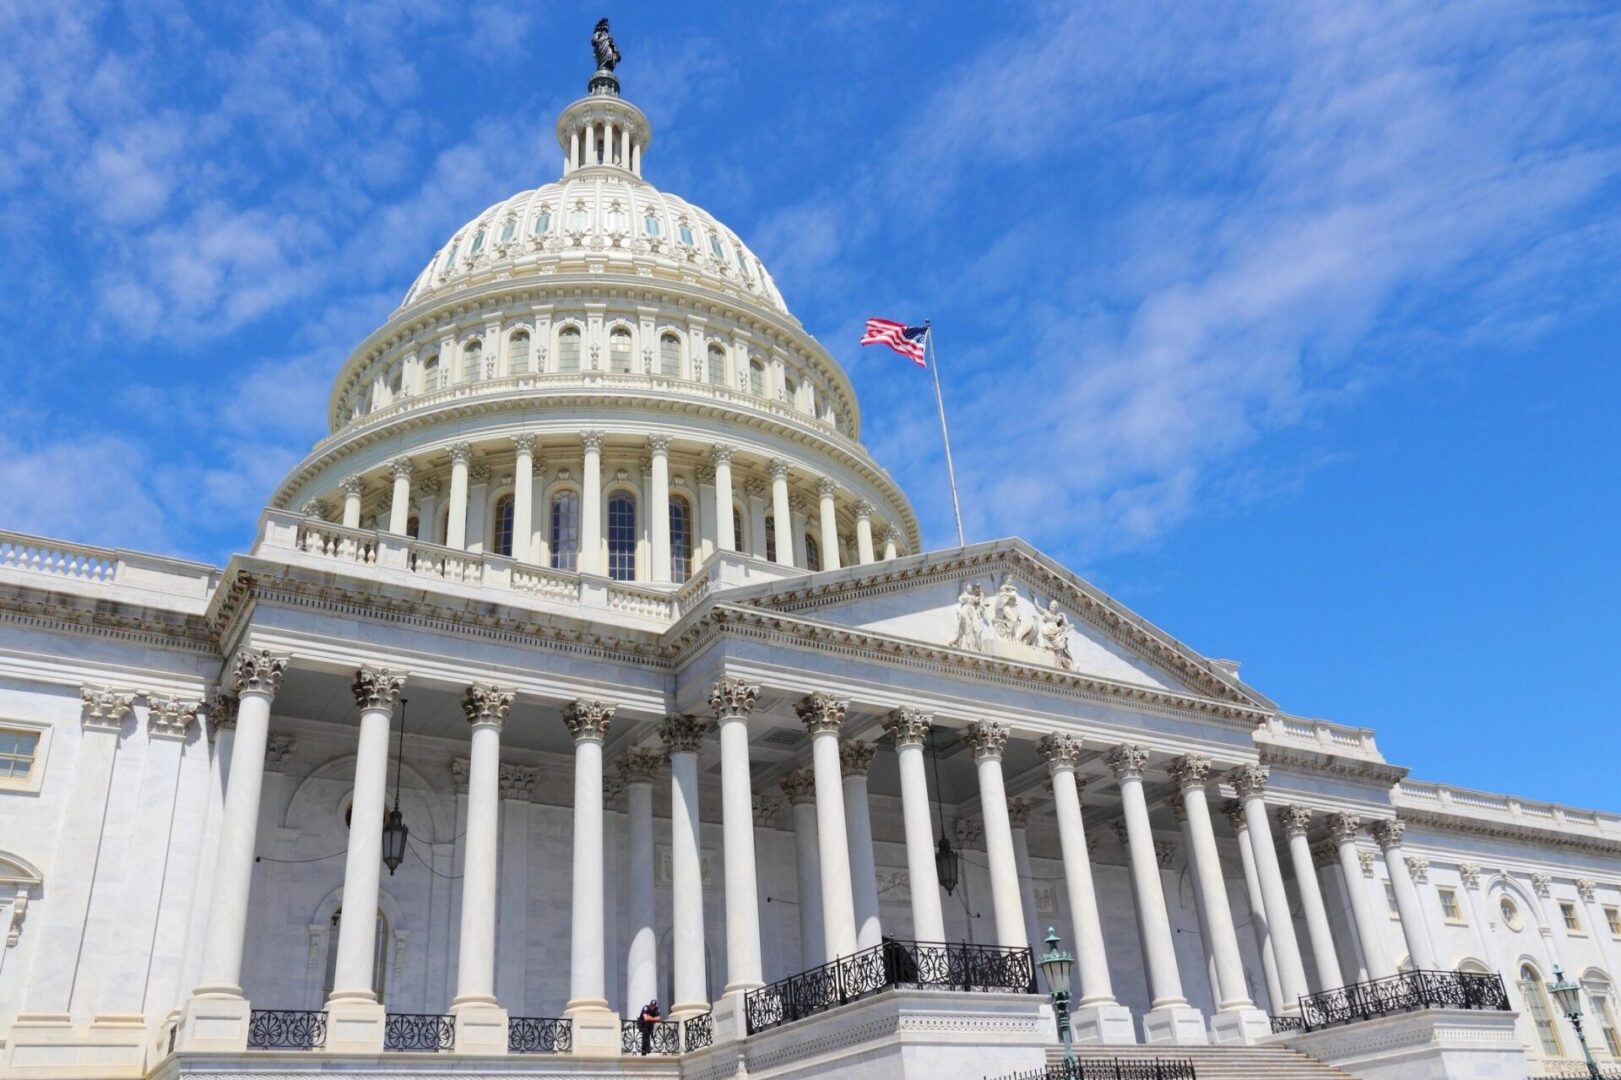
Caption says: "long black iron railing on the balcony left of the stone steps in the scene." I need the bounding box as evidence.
[742,941,1036,1035]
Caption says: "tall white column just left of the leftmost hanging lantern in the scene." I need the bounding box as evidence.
[319,666,405,1052]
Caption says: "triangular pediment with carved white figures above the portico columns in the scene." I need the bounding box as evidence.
[725,540,1272,709]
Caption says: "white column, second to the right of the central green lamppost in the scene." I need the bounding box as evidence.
[1104,743,1208,1043]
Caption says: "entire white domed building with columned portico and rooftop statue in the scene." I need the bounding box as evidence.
[0,24,1621,1080]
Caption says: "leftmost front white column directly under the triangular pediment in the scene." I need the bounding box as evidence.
[710,678,765,994]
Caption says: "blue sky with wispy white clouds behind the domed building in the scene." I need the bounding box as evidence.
[0,0,1621,809]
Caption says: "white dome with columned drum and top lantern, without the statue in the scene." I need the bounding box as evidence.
[272,37,919,584]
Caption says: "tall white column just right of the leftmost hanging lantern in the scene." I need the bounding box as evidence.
[451,684,512,1054]
